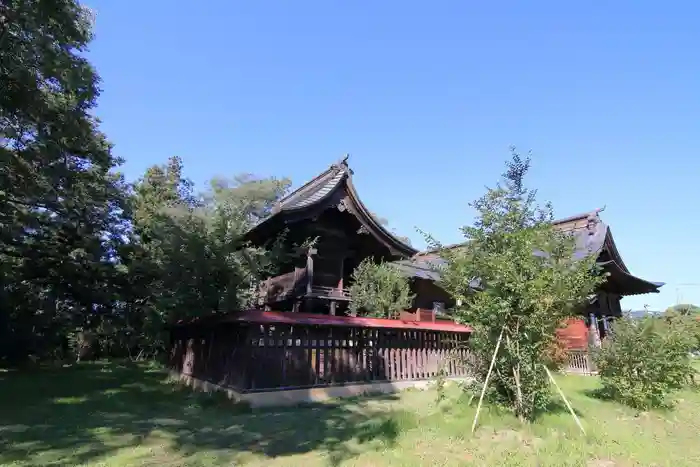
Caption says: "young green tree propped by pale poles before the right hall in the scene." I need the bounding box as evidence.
[428,149,602,419]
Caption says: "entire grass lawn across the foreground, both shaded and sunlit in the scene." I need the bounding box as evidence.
[0,363,700,467]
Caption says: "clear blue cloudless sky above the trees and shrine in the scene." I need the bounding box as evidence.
[87,0,700,309]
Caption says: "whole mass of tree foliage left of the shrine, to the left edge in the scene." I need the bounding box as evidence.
[0,0,289,363]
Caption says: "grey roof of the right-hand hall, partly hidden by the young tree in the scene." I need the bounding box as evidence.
[397,209,664,295]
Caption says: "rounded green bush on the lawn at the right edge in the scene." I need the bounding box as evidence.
[594,314,695,410]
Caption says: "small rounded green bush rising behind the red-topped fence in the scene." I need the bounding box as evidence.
[350,258,414,318]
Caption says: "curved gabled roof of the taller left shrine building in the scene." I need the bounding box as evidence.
[248,155,418,258]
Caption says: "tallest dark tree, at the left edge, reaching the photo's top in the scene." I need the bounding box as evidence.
[0,0,128,359]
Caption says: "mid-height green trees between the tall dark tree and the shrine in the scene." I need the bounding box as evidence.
[124,157,290,354]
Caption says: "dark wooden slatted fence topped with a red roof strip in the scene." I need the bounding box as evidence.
[170,311,471,393]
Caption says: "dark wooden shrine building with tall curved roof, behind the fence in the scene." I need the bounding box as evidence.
[246,157,451,315]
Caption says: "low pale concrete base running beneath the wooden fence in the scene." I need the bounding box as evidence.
[170,372,469,407]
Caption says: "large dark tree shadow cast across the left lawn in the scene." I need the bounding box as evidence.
[0,363,415,465]
